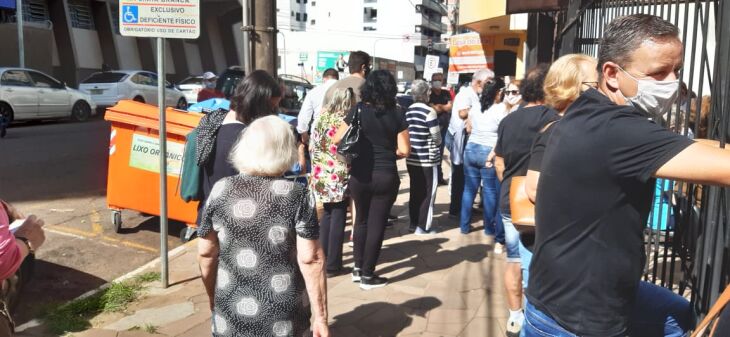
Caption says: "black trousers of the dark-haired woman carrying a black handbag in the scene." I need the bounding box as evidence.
[349,171,400,276]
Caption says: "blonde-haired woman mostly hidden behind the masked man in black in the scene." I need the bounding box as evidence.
[525,54,598,202]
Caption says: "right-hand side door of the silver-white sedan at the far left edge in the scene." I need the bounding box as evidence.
[28,70,73,117]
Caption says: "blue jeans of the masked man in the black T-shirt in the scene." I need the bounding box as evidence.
[520,282,692,337]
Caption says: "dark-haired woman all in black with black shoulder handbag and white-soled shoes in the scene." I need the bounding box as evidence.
[335,70,410,290]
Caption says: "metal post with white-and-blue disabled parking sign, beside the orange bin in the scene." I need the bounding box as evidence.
[119,0,200,288]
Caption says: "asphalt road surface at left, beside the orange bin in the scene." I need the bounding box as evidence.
[0,118,184,323]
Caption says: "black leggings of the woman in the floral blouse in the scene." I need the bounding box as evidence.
[319,200,348,271]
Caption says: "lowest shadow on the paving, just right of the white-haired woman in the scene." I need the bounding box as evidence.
[332,297,442,337]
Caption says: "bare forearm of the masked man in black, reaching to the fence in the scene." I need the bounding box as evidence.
[654,141,730,186]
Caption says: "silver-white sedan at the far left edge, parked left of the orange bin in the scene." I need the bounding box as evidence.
[0,68,96,121]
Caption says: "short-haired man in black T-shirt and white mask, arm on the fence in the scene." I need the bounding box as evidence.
[523,14,730,337]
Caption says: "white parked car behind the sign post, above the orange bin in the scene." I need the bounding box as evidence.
[79,70,188,109]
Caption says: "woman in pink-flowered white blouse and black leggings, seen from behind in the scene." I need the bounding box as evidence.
[309,88,355,277]
